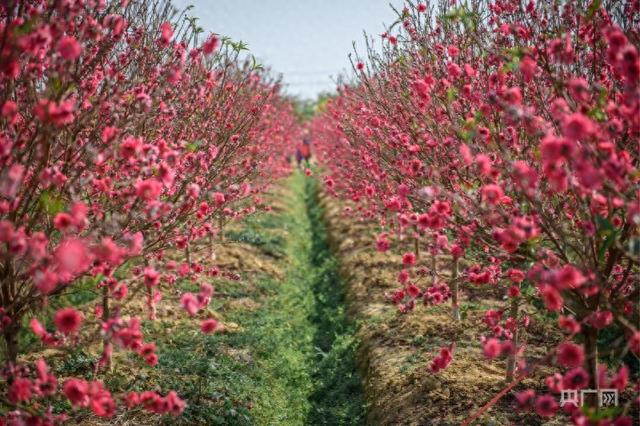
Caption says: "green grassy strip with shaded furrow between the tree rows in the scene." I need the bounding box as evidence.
[149,173,365,426]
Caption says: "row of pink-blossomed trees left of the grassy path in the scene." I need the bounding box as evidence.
[0,0,296,424]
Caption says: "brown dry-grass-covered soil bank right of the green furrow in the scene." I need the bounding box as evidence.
[321,196,551,425]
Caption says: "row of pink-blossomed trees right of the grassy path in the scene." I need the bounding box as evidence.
[312,0,640,425]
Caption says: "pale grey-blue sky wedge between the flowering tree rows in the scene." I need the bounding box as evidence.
[173,0,402,98]
